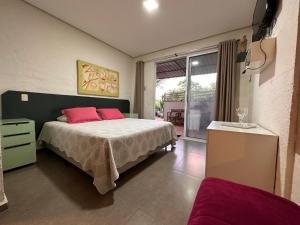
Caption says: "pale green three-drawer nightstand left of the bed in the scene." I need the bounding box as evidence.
[0,119,36,171]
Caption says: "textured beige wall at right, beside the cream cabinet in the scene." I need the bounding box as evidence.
[252,0,300,203]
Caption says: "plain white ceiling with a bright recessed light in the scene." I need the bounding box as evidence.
[25,0,256,57]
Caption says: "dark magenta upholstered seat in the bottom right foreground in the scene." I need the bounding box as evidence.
[188,178,300,225]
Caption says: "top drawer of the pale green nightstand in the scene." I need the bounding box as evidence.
[1,121,34,136]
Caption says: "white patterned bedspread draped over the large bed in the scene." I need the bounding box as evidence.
[38,118,177,194]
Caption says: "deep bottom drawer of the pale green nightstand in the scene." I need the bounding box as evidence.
[2,143,36,170]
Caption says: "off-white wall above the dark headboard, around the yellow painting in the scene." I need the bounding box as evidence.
[0,0,133,116]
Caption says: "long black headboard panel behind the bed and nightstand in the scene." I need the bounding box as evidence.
[1,91,130,135]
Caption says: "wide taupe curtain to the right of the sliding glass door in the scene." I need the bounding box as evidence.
[215,40,237,121]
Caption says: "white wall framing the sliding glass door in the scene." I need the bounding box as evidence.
[134,28,251,119]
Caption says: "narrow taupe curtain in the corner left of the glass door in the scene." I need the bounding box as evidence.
[133,61,144,118]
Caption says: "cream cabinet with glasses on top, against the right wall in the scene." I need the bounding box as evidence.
[205,121,278,193]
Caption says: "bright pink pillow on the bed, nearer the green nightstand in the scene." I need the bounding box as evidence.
[63,107,101,123]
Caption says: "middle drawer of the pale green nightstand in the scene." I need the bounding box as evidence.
[2,132,35,149]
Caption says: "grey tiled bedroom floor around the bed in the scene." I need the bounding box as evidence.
[0,140,205,225]
